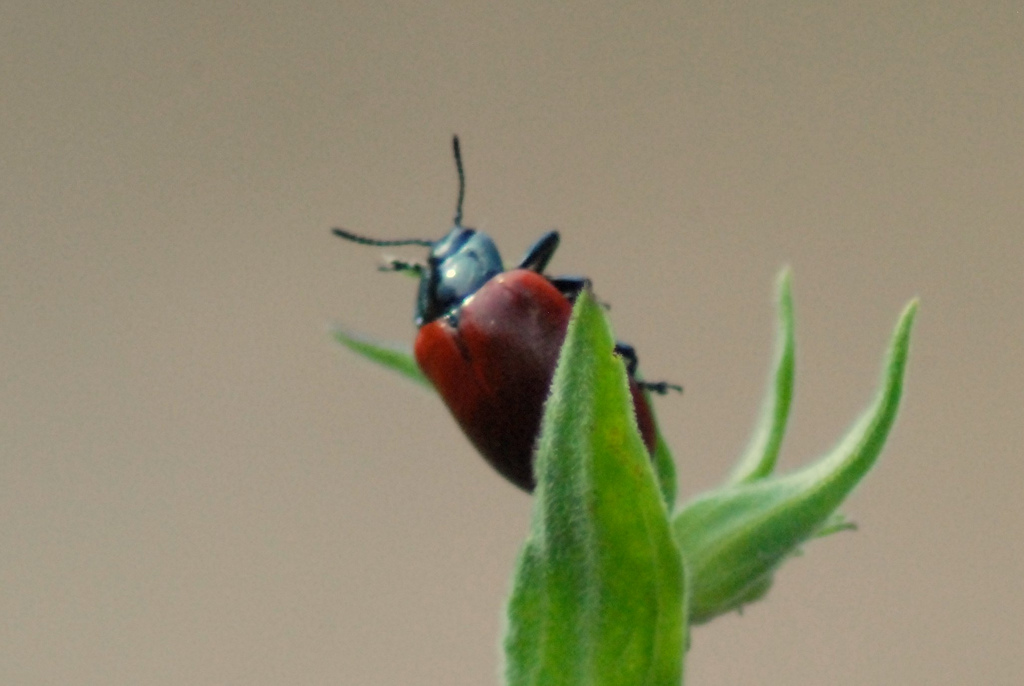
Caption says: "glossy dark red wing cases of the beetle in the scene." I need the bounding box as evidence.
[414,269,656,490]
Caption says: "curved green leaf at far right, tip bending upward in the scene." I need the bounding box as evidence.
[674,301,918,623]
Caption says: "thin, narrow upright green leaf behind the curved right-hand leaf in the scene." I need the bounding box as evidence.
[728,269,796,483]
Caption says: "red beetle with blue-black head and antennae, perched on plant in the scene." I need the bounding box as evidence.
[332,136,682,491]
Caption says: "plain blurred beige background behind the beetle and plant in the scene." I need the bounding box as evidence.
[0,1,1024,685]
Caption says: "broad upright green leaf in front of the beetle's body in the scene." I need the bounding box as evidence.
[505,293,685,686]
